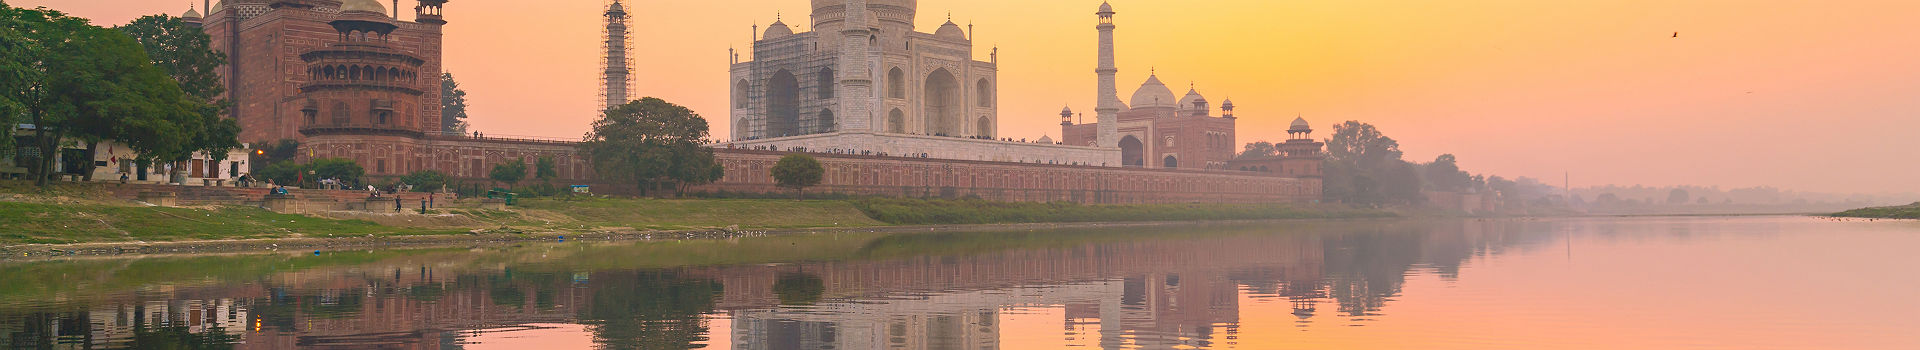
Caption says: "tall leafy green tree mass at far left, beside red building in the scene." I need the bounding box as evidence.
[0,8,215,187]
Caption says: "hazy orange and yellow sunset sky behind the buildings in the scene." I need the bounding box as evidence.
[8,0,1920,192]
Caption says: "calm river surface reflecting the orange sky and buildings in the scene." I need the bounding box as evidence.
[0,217,1920,350]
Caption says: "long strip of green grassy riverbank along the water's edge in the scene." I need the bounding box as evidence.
[0,185,1394,246]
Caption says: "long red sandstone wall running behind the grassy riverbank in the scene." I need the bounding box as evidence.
[300,135,1321,204]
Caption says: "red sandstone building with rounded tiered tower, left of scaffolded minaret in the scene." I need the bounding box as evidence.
[204,0,445,142]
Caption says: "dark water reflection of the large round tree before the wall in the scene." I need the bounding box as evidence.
[580,271,722,350]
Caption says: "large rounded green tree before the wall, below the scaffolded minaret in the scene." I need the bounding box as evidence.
[580,98,714,196]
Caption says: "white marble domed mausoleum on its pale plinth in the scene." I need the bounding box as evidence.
[726,0,1119,165]
